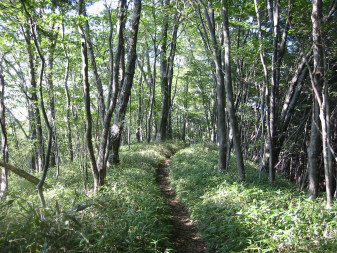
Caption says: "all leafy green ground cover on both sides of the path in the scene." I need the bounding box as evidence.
[0,143,337,252]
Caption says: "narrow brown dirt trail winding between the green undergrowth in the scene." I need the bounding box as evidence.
[156,159,206,253]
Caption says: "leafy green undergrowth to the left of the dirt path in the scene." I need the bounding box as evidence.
[0,143,183,252]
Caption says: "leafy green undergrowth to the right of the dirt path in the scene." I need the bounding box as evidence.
[169,144,337,252]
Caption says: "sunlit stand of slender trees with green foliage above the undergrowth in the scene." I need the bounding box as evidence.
[0,0,337,251]
